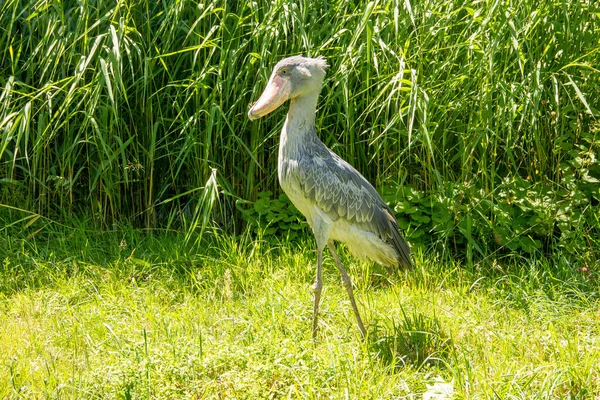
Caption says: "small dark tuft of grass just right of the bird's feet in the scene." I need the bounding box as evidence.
[368,309,454,369]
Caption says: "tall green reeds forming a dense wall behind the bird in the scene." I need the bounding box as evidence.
[0,0,600,231]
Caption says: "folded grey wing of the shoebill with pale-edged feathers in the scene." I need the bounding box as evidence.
[289,147,411,267]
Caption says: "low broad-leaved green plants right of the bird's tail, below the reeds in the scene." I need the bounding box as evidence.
[384,122,600,265]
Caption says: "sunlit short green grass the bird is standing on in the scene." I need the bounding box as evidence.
[0,229,600,399]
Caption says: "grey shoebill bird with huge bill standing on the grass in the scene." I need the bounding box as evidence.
[248,56,411,338]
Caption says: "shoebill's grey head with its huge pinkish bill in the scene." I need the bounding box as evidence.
[248,56,327,120]
